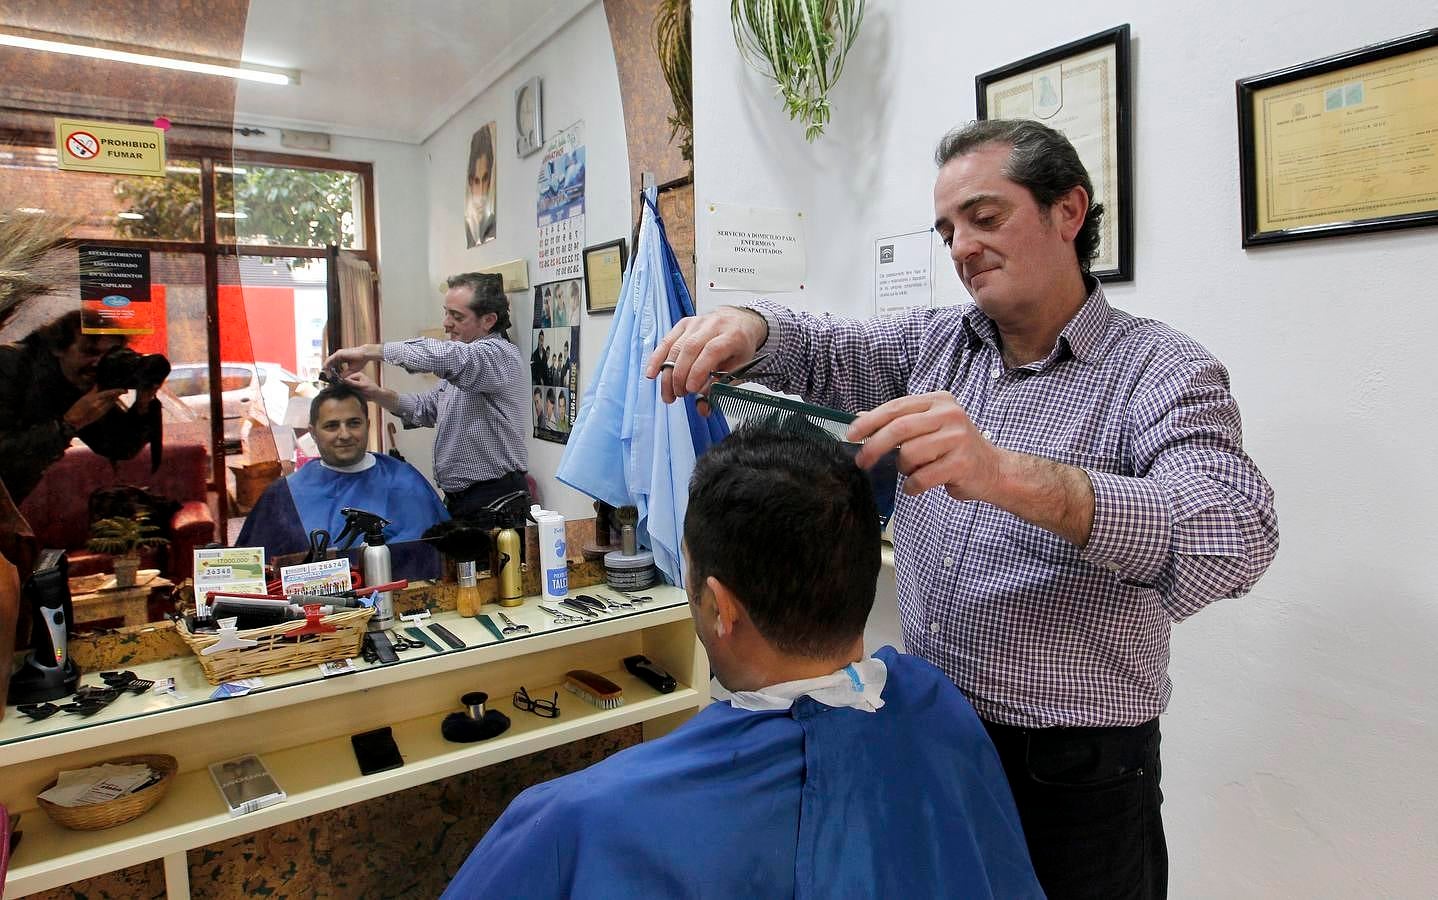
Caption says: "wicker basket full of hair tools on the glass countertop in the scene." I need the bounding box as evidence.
[175,608,374,684]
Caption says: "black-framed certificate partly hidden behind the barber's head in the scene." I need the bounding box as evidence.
[974,24,1133,282]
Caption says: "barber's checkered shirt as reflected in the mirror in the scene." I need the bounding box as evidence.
[384,334,529,493]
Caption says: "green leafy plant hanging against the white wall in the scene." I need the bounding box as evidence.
[729,0,864,141]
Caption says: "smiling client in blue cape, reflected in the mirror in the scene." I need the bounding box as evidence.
[237,385,449,556]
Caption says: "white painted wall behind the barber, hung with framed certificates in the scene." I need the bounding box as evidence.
[695,0,1438,897]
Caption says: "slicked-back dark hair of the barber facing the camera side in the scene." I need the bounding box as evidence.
[933,119,1103,272]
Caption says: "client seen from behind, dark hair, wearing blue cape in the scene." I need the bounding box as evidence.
[446,428,1043,897]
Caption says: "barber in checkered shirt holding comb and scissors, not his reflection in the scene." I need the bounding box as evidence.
[647,121,1278,899]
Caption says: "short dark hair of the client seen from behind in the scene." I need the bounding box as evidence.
[684,424,880,658]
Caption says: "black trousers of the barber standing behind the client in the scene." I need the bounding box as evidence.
[984,719,1168,900]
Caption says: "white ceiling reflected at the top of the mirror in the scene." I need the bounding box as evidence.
[234,0,598,144]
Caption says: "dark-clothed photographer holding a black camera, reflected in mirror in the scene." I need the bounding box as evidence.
[0,311,170,503]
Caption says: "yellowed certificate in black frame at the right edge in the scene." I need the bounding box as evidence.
[1237,29,1438,247]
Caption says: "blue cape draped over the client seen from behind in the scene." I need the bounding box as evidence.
[444,647,1043,899]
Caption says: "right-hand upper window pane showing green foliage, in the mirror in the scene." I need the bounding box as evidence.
[214,162,364,249]
